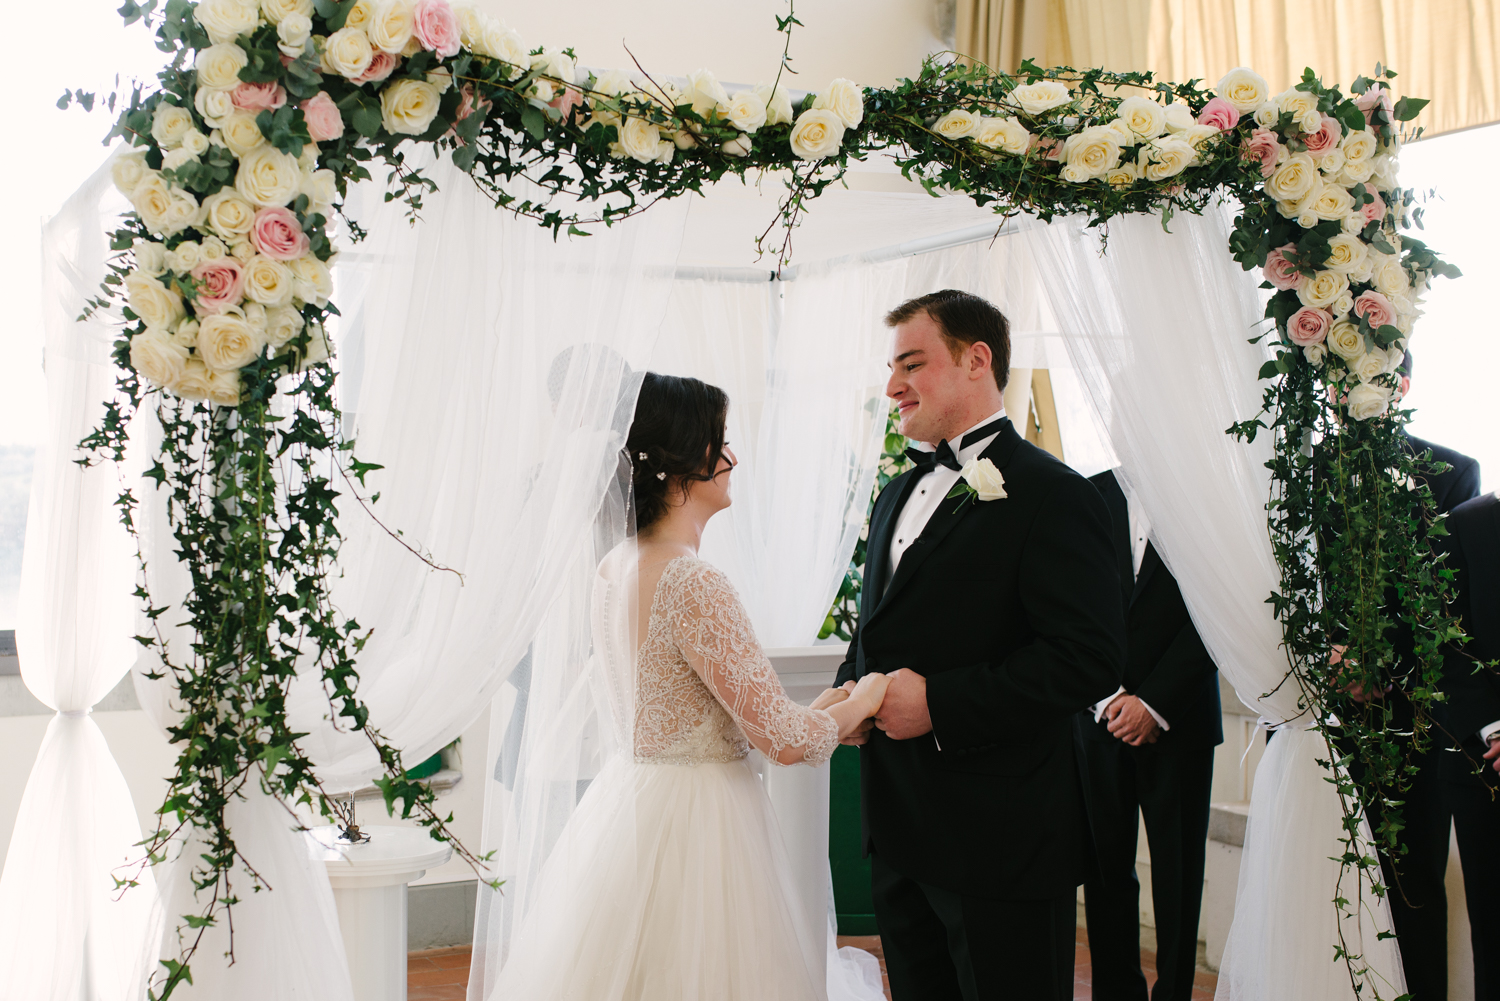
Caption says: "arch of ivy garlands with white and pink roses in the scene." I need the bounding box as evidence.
[49,0,1458,996]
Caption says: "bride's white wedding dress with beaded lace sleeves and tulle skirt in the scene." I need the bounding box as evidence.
[491,557,882,1001]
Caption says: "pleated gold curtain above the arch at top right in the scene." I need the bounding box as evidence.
[957,0,1500,135]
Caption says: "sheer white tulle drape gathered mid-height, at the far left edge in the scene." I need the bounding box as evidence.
[0,154,155,1001]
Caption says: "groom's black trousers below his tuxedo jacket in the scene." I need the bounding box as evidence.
[870,852,1079,1001]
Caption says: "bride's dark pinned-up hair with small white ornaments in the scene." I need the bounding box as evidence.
[626,372,729,531]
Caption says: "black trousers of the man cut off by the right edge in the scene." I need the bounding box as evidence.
[1442,762,1500,1001]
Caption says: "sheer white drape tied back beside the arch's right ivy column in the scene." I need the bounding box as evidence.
[1026,210,1403,1001]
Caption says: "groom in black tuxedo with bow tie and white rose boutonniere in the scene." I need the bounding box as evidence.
[839,290,1125,1001]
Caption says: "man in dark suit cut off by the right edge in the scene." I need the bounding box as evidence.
[1437,494,1500,1001]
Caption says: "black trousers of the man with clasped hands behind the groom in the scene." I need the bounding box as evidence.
[1083,740,1214,1001]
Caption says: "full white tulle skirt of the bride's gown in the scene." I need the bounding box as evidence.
[491,759,881,1001]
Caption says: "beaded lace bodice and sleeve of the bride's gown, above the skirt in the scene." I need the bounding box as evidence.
[633,557,839,765]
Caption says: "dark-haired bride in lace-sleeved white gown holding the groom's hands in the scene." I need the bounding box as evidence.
[489,374,887,1001]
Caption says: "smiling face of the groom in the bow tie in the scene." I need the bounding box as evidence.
[885,312,972,444]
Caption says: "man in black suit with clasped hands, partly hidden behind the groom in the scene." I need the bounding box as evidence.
[1079,471,1224,1001]
